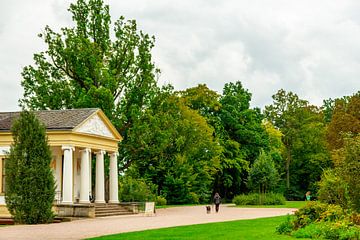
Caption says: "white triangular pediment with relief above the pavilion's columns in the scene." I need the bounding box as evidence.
[74,113,116,139]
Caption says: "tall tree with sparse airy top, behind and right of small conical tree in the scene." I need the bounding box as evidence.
[264,90,331,198]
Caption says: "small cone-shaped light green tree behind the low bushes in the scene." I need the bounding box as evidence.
[248,150,279,194]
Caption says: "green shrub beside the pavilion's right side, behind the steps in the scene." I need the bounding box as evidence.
[119,176,155,202]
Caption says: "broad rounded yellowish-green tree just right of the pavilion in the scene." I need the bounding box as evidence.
[120,89,221,204]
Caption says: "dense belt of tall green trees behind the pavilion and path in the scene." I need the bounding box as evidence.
[20,0,360,203]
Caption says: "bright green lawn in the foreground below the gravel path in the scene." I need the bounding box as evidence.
[87,216,310,240]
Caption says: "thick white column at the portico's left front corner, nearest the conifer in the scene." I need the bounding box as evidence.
[61,146,74,204]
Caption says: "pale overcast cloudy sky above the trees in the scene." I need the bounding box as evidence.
[0,0,360,111]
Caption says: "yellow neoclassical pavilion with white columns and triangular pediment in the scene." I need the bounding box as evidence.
[0,109,122,216]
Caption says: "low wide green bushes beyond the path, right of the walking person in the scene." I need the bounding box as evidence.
[233,193,285,205]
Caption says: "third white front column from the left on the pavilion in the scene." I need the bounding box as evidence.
[95,150,105,203]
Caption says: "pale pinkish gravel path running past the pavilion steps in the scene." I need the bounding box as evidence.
[0,205,296,240]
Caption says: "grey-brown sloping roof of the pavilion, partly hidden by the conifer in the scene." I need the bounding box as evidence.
[0,108,99,131]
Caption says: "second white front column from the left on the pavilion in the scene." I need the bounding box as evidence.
[80,148,91,203]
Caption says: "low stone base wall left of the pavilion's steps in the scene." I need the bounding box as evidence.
[53,204,95,218]
